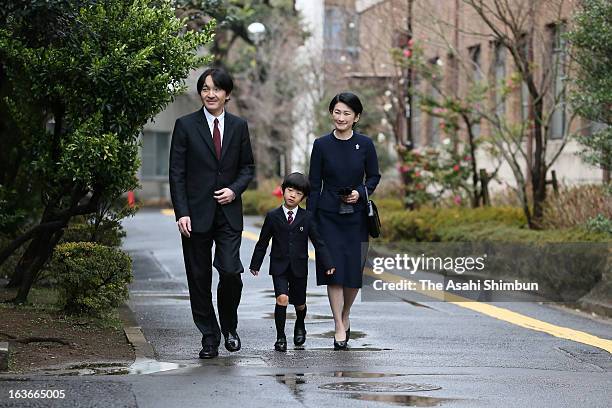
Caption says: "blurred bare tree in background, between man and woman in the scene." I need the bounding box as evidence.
[177,0,309,184]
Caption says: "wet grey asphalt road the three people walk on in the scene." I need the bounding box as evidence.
[0,210,612,407]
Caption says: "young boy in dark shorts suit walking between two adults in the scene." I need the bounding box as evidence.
[249,173,335,351]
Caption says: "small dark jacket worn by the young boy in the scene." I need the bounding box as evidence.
[250,207,334,277]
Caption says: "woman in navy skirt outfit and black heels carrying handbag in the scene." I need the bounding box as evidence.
[307,92,380,350]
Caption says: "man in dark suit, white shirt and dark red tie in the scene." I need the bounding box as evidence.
[169,68,254,358]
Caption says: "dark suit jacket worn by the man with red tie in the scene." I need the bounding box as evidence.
[169,109,255,232]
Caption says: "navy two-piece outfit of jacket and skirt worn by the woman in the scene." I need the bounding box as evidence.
[307,132,380,288]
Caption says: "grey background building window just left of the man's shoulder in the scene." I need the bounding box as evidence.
[140,130,170,180]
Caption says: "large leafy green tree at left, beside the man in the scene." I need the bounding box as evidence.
[0,0,214,302]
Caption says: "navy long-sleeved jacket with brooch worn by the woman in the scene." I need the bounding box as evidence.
[307,132,380,213]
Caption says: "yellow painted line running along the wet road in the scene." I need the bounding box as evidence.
[162,210,612,353]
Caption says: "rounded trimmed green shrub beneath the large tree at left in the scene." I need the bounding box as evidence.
[47,242,133,317]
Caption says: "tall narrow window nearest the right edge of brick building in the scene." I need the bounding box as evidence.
[549,24,567,139]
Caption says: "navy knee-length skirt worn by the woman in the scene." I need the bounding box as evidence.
[317,209,368,288]
